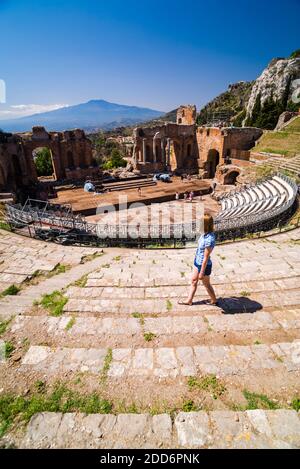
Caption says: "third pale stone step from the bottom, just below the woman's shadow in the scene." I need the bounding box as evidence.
[11,309,300,347]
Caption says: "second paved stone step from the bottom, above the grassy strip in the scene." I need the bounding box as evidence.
[19,340,300,380]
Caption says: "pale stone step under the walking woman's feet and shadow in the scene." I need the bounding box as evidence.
[64,289,300,314]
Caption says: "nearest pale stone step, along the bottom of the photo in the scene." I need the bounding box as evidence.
[20,409,300,448]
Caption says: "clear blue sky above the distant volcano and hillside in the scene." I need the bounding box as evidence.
[0,0,300,119]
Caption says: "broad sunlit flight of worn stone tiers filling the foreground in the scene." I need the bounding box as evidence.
[0,229,300,448]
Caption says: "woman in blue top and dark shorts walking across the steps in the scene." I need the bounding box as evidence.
[178,214,217,306]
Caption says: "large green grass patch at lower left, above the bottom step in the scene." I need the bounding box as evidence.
[0,383,112,437]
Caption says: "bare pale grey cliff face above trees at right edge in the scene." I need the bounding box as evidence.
[246,57,300,117]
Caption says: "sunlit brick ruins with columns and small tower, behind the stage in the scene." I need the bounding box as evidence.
[133,106,262,178]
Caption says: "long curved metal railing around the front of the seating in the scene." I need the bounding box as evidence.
[7,174,298,245]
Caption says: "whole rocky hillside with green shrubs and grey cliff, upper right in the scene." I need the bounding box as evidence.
[197,49,300,129]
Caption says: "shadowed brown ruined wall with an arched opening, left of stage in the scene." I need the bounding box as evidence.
[0,127,97,190]
